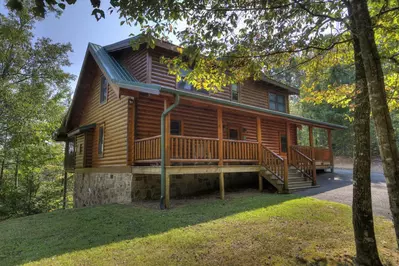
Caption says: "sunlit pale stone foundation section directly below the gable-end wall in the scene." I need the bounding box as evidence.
[73,173,132,208]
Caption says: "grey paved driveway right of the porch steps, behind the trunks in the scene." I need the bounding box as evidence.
[296,169,392,219]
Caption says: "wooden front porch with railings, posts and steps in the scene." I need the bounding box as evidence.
[131,104,333,206]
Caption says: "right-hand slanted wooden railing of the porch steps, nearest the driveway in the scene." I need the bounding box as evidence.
[290,146,316,184]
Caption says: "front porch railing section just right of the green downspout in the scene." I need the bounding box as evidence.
[170,135,218,162]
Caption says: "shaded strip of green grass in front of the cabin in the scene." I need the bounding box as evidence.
[0,193,300,265]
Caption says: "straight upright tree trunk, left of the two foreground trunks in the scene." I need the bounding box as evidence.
[349,5,382,266]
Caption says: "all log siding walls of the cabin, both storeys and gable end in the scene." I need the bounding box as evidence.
[69,48,297,168]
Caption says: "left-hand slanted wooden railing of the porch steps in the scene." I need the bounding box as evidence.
[262,145,288,189]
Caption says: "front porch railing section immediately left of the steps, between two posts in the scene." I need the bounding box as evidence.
[223,139,258,162]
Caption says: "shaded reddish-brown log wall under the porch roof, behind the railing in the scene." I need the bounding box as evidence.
[135,94,296,154]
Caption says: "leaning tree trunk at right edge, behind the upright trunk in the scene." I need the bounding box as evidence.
[351,0,399,247]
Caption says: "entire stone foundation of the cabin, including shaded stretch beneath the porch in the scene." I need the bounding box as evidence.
[74,173,258,208]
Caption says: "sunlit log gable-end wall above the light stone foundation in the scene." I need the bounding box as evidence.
[80,68,128,167]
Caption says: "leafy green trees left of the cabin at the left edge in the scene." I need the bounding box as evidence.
[0,10,72,219]
